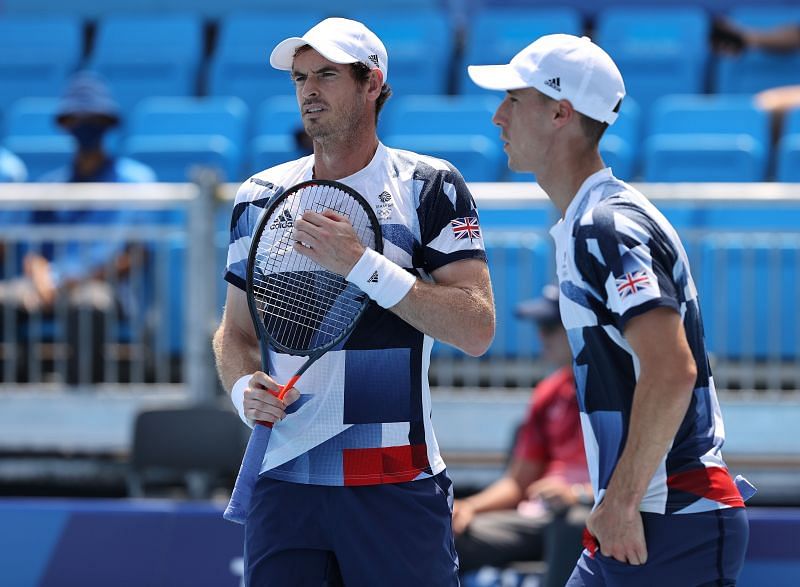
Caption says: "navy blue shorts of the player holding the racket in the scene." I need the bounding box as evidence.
[244,472,459,587]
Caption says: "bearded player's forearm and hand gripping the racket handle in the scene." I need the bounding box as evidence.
[213,285,300,422]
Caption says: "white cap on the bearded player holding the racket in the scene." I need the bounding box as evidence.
[269,18,389,83]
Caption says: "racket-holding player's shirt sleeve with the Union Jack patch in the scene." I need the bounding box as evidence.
[415,163,486,273]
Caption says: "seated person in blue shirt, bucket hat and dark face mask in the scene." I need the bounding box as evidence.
[0,72,156,384]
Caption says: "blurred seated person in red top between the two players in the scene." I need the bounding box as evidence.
[453,285,593,587]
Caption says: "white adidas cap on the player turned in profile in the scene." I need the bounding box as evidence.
[467,34,625,124]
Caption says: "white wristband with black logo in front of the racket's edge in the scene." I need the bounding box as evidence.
[346,248,417,308]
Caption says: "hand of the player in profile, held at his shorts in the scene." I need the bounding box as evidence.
[586,500,647,565]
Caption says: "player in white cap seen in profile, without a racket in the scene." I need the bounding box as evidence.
[469,34,748,587]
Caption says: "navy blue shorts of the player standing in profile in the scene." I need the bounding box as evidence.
[567,508,750,587]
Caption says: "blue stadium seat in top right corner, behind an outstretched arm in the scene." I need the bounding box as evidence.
[714,6,800,94]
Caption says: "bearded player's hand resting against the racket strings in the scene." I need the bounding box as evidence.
[294,210,364,276]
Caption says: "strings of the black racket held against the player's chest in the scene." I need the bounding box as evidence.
[253,185,375,350]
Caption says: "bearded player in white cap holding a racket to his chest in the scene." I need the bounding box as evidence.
[214,18,494,587]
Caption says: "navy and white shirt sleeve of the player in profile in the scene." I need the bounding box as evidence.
[575,204,680,330]
